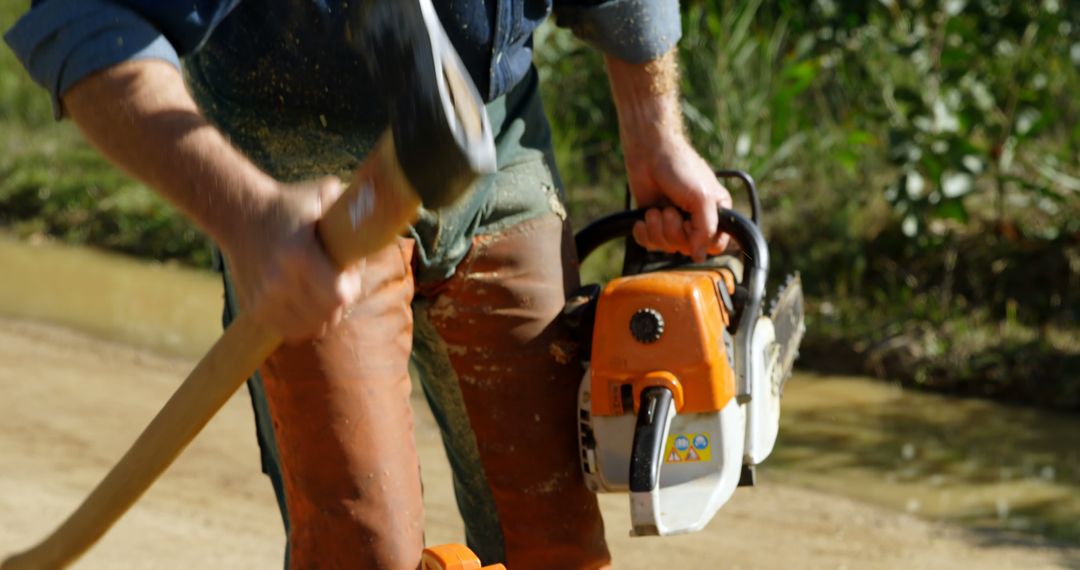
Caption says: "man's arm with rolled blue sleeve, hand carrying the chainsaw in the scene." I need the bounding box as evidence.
[555,0,731,260]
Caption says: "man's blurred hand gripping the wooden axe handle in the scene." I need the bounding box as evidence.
[222,177,362,342]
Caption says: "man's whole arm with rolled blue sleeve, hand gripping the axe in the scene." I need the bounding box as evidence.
[8,0,360,340]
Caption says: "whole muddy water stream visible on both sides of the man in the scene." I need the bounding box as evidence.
[0,238,1080,542]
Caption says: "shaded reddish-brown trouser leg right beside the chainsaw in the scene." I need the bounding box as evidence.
[418,215,609,570]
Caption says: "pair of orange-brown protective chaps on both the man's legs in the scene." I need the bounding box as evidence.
[252,215,609,570]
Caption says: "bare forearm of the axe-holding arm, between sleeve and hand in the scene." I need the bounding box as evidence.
[64,60,275,248]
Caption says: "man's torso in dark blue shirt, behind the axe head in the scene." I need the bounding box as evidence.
[189,0,551,124]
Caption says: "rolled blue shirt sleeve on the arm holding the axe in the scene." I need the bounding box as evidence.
[4,0,235,119]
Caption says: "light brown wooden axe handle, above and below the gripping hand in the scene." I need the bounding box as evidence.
[0,132,420,570]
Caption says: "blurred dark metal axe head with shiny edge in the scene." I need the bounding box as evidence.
[348,0,496,208]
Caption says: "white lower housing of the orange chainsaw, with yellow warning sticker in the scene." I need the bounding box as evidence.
[578,317,780,535]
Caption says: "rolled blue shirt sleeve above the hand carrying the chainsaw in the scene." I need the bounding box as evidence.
[555,0,683,64]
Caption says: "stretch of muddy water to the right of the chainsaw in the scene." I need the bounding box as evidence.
[761,375,1080,542]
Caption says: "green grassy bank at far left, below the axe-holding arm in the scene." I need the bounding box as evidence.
[0,0,211,267]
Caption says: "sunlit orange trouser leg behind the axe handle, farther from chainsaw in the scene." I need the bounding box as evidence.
[253,240,423,570]
